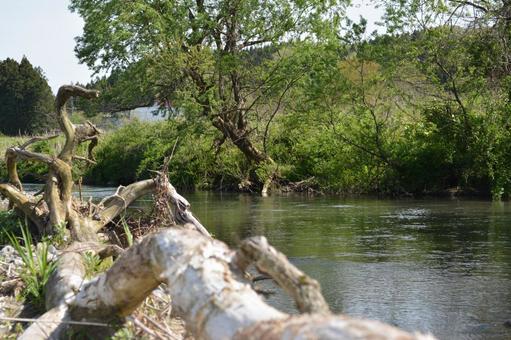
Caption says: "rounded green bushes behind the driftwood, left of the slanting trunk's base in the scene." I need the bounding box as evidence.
[86,121,246,189]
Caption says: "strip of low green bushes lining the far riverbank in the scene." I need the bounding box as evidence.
[0,120,509,200]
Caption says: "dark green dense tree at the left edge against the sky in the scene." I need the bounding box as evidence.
[0,57,56,135]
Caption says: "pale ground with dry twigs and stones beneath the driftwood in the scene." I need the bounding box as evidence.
[0,226,193,339]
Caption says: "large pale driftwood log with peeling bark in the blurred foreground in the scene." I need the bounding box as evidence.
[22,228,433,340]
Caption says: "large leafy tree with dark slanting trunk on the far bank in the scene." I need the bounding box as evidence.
[71,0,344,191]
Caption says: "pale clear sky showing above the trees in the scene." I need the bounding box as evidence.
[0,0,380,93]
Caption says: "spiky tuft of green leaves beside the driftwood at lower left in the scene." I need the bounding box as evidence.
[7,225,56,310]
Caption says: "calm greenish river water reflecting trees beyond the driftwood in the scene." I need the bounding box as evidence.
[22,188,511,339]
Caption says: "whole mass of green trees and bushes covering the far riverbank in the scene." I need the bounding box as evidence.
[63,0,511,199]
